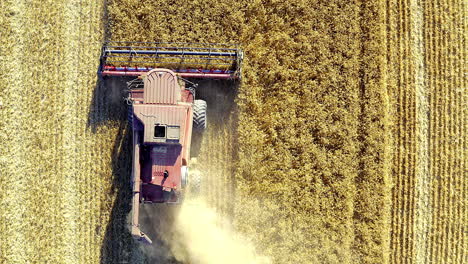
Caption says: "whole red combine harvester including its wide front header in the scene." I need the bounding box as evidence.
[99,42,243,244]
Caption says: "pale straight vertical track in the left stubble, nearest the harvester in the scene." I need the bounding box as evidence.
[60,1,81,263]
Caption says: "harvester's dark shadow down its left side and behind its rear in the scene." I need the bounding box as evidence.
[88,77,179,264]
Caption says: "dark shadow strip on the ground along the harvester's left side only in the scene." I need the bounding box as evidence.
[88,75,142,263]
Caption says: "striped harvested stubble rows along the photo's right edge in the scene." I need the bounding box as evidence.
[387,0,468,263]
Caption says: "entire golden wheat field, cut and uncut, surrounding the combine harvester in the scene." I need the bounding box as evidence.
[0,0,468,264]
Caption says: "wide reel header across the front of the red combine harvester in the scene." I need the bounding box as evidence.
[99,41,243,79]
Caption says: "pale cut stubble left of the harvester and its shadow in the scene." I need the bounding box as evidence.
[0,1,137,263]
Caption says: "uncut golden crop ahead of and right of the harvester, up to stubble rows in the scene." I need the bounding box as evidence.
[109,1,390,263]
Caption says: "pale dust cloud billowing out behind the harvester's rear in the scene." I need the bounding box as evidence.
[137,198,272,264]
